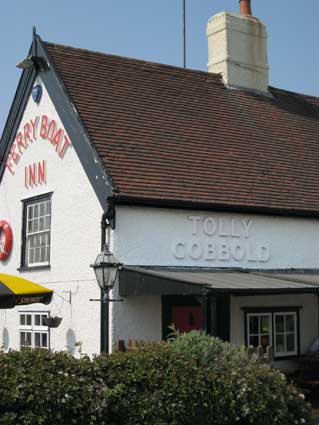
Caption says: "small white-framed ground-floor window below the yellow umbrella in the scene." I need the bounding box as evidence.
[19,311,49,348]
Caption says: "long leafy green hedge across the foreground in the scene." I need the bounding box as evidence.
[0,332,311,425]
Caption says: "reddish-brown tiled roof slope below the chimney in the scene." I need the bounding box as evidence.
[45,43,319,214]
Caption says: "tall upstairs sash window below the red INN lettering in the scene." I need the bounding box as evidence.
[21,194,51,268]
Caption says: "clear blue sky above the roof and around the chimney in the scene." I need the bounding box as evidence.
[0,0,319,134]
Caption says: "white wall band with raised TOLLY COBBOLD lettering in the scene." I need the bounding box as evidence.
[114,206,319,269]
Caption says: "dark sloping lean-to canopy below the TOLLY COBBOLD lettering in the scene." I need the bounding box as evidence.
[119,266,319,297]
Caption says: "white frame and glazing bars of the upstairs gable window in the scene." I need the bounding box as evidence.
[21,193,52,268]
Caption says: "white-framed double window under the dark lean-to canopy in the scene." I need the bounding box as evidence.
[246,310,299,357]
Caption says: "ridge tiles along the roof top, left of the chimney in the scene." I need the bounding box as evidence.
[42,41,222,82]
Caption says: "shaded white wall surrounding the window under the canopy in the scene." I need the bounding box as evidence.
[230,294,319,354]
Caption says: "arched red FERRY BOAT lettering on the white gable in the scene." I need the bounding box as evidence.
[6,115,71,175]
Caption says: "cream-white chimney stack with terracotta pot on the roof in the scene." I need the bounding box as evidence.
[206,0,269,93]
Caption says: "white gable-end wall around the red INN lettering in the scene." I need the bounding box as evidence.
[0,80,102,354]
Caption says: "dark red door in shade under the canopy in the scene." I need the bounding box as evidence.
[172,305,201,332]
